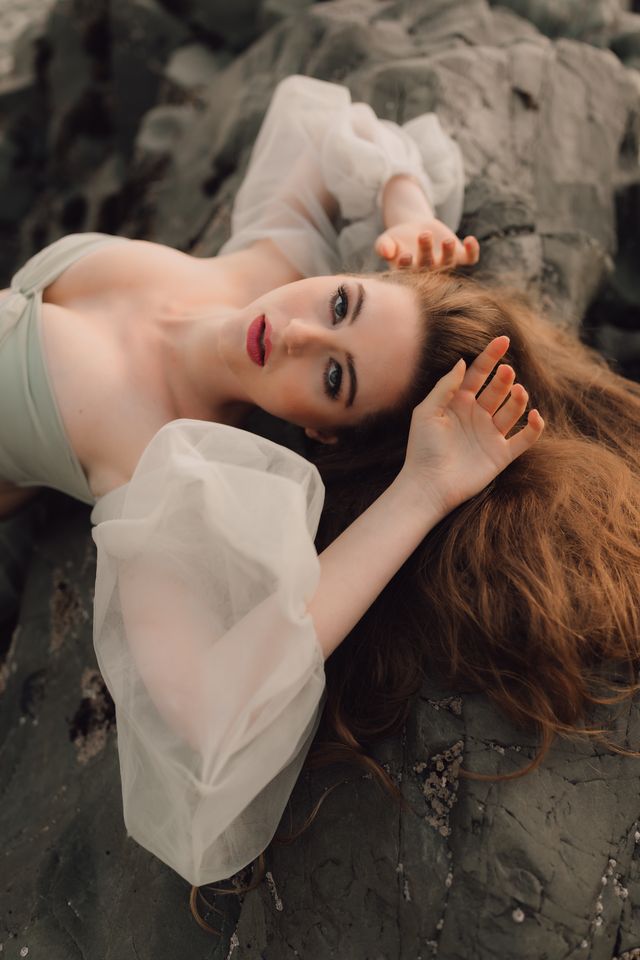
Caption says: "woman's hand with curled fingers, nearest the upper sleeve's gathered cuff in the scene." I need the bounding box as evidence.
[375,218,480,270]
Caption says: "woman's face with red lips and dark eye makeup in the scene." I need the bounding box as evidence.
[223,276,421,439]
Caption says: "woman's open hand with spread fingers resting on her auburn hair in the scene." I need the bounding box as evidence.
[402,336,544,516]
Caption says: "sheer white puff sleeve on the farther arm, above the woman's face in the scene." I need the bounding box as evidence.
[219,75,464,276]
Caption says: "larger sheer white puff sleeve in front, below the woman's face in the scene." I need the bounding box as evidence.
[91,420,325,885]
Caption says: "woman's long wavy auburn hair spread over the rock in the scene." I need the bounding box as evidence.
[192,270,640,928]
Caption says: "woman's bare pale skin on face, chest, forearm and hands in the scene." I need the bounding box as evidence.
[0,169,544,673]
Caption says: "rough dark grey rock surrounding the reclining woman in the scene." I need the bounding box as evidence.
[0,0,640,960]
